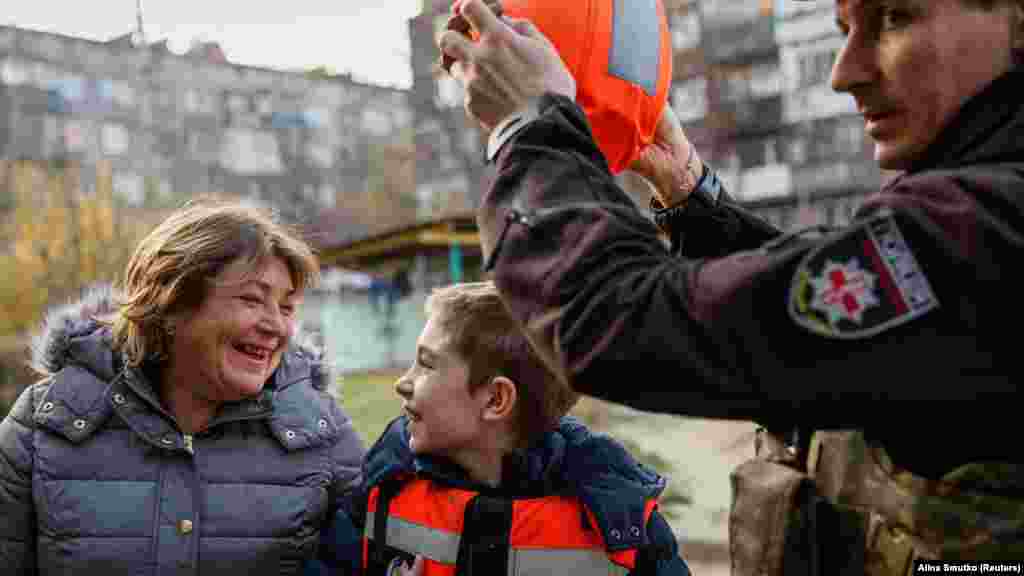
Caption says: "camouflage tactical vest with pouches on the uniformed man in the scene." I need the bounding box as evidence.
[729,429,1024,576]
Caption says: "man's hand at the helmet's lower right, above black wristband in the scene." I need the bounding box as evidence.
[630,105,703,207]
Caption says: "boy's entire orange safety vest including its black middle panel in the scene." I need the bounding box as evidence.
[362,479,656,576]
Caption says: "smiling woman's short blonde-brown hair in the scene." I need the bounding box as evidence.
[111,199,319,366]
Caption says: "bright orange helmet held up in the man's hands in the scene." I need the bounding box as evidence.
[453,0,672,173]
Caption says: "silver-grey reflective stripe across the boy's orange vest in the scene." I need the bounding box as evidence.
[362,515,629,576]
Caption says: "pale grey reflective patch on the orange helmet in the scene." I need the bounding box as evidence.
[608,0,662,96]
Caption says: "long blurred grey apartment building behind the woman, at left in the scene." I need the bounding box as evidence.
[0,27,416,220]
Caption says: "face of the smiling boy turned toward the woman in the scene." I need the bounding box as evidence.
[395,314,487,455]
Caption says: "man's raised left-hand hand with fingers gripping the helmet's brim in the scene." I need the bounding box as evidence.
[437,0,575,132]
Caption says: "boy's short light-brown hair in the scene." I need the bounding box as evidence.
[425,282,579,443]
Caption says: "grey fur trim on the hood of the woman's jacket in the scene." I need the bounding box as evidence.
[30,284,333,389]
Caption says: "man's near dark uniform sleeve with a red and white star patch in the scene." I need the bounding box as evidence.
[478,95,1021,426]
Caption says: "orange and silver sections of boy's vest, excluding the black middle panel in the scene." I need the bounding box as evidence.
[362,479,656,576]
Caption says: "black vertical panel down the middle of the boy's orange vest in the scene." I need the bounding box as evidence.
[456,494,513,576]
